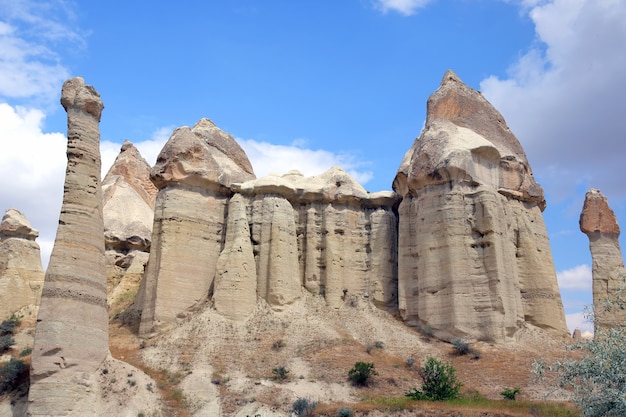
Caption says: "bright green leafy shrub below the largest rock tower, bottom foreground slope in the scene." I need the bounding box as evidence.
[404,357,463,401]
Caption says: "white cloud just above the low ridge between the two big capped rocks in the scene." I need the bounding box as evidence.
[237,139,373,185]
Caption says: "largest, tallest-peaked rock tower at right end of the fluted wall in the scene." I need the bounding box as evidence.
[393,71,567,341]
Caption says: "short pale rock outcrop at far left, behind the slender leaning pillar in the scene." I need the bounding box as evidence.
[0,209,44,318]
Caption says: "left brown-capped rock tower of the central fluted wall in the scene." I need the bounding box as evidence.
[140,119,254,335]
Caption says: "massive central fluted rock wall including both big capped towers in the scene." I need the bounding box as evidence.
[140,72,567,341]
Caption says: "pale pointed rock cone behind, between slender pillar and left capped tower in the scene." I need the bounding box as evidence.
[102,141,157,304]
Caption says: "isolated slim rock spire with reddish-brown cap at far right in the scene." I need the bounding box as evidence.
[580,189,626,325]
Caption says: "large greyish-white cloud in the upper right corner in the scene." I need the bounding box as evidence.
[481,0,626,197]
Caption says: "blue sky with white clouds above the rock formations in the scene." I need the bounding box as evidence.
[0,0,626,327]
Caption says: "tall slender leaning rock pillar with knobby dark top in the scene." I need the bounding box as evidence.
[28,77,109,416]
